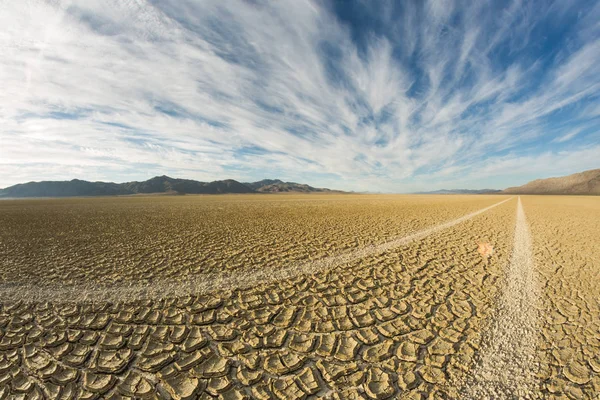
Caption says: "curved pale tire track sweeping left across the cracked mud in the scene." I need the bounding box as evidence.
[0,197,514,302]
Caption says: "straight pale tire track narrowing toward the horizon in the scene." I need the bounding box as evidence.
[461,197,540,399]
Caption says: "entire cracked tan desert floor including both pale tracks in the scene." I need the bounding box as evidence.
[0,194,600,399]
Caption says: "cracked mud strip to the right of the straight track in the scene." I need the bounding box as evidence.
[522,196,600,399]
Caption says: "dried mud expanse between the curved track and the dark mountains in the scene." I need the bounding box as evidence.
[0,195,506,287]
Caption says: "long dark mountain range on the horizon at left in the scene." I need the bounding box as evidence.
[0,175,344,198]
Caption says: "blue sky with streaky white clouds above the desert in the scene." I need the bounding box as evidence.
[0,0,600,192]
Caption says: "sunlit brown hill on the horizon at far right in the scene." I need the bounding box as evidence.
[503,169,600,195]
